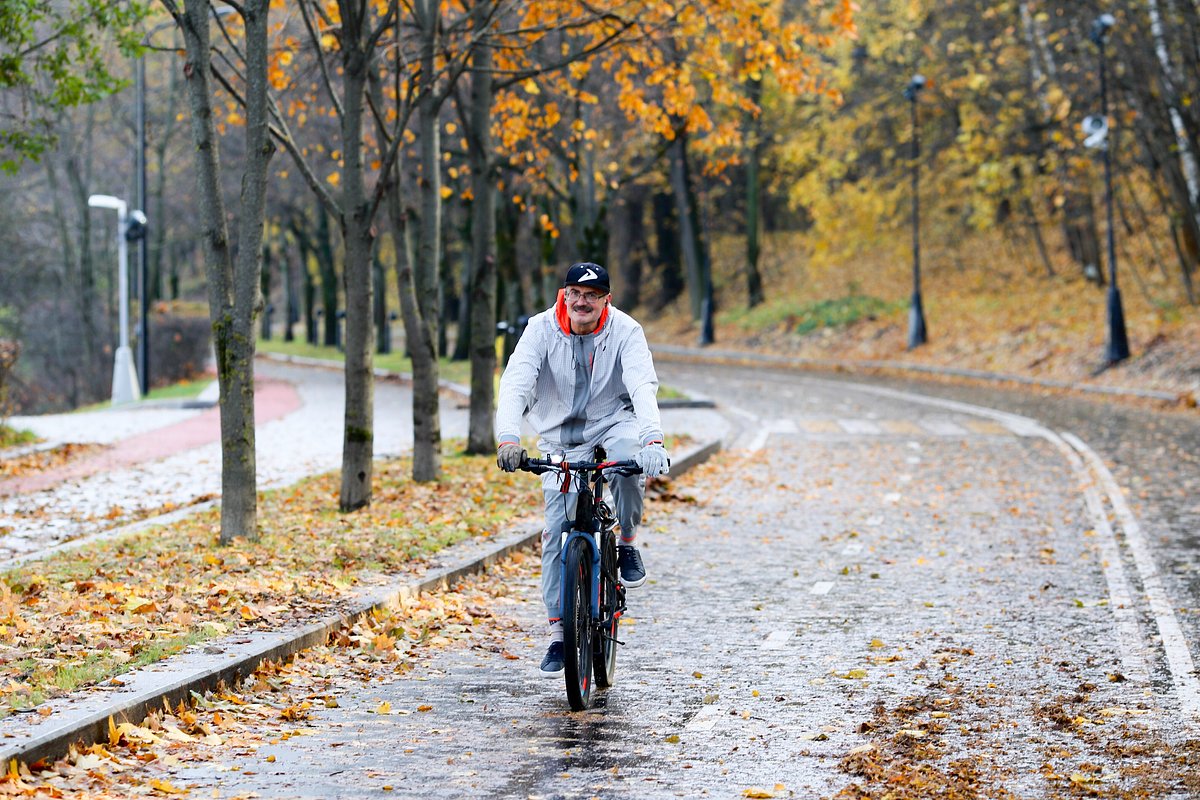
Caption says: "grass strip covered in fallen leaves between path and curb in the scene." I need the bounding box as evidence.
[0,455,540,715]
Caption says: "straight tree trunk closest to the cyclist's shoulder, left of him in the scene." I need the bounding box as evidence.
[466,0,496,455]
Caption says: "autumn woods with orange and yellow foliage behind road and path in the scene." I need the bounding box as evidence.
[0,0,1200,532]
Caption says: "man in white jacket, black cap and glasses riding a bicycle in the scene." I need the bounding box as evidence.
[496,263,670,675]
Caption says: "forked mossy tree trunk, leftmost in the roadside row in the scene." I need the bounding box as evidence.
[171,0,274,543]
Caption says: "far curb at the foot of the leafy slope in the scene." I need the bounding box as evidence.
[650,344,1187,403]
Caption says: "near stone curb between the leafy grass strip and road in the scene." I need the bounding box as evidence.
[0,440,721,764]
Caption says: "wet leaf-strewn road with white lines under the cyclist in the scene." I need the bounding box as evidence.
[159,363,1200,798]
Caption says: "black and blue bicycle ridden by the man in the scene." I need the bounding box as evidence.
[520,447,642,711]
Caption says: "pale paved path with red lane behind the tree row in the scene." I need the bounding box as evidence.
[0,360,467,561]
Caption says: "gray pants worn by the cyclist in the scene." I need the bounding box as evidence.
[541,427,646,621]
